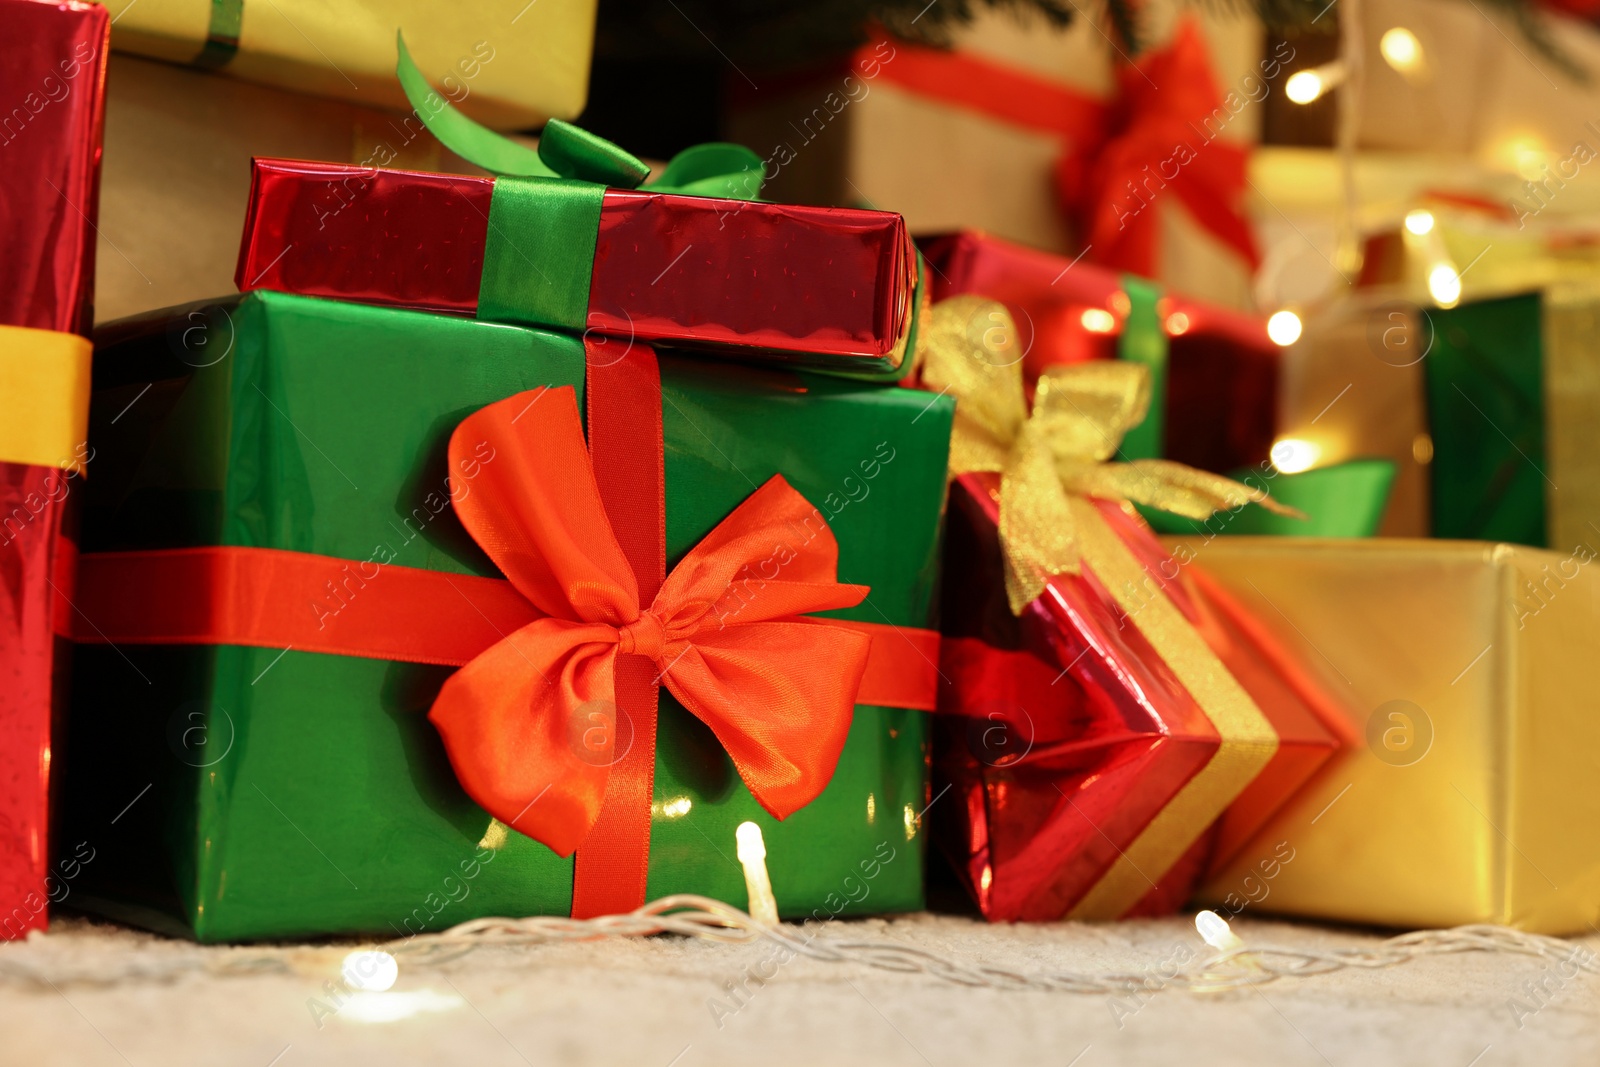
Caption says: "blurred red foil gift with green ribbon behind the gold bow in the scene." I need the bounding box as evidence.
[918,230,1282,470]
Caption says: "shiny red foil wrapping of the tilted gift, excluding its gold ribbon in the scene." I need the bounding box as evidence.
[934,475,1341,921]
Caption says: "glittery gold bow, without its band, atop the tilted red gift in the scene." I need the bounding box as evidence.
[920,294,1299,614]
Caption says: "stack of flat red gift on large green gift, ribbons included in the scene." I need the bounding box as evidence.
[66,45,952,939]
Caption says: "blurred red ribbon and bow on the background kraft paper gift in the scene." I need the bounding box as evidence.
[856,18,1261,277]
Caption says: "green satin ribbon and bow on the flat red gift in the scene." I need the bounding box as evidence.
[395,32,763,331]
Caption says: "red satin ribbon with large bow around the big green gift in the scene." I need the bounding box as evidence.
[74,383,938,913]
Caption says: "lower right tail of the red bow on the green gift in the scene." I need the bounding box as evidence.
[662,619,872,819]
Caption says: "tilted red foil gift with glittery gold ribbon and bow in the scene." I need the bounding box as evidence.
[920,296,1341,920]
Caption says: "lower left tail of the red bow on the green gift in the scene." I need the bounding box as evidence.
[427,619,618,856]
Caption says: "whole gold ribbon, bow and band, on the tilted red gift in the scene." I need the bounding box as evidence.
[918,296,1298,918]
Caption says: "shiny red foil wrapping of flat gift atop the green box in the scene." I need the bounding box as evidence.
[235,160,917,360]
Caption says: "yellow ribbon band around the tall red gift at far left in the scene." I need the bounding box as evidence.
[0,326,94,474]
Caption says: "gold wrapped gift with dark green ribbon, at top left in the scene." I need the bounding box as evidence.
[106,0,595,130]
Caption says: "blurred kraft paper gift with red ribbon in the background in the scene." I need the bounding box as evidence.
[726,0,1278,307]
